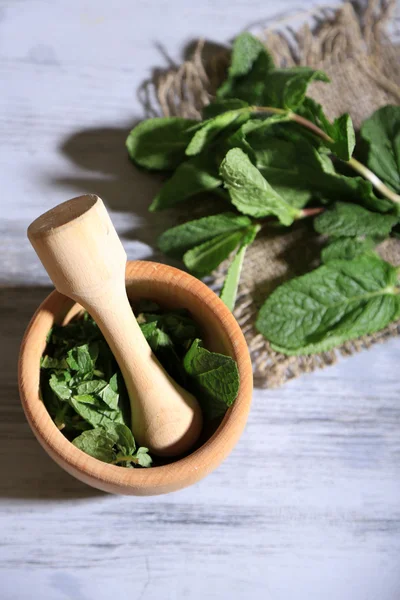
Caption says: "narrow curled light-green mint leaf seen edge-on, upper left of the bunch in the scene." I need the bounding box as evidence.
[186,108,250,156]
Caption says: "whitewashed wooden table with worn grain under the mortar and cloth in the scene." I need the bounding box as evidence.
[0,0,400,600]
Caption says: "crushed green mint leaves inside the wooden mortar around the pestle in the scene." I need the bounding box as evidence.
[41,301,239,467]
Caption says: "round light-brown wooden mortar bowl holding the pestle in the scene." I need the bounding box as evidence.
[18,261,253,496]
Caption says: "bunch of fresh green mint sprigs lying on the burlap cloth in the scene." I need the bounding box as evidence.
[127,33,400,354]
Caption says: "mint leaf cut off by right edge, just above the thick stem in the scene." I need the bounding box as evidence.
[361,105,400,192]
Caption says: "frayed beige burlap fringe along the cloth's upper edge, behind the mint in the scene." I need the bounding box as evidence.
[151,0,400,119]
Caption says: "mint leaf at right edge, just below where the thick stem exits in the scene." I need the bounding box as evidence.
[314,202,398,238]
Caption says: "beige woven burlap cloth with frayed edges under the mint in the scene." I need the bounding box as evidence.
[145,0,400,387]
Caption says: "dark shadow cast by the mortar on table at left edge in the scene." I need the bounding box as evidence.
[0,286,104,501]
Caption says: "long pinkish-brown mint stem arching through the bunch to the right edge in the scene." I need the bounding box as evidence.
[251,106,400,209]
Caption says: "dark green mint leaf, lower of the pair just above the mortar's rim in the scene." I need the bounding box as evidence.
[183,230,244,277]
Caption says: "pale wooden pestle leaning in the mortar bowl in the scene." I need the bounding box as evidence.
[28,195,202,456]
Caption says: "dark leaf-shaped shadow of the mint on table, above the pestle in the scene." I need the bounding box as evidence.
[49,35,231,251]
